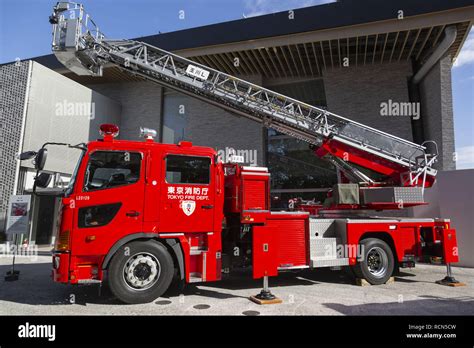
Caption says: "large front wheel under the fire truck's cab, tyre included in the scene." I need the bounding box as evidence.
[108,240,174,303]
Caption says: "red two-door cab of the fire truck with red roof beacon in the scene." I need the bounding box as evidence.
[53,125,224,300]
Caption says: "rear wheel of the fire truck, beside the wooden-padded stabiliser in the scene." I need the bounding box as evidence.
[352,238,395,285]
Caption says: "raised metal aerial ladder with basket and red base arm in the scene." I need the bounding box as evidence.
[50,2,437,209]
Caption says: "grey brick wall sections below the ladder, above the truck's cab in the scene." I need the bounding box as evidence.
[89,76,266,165]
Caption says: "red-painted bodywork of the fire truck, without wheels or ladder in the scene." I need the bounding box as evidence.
[53,136,458,283]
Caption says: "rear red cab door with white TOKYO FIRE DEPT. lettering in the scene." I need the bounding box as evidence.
[159,152,216,232]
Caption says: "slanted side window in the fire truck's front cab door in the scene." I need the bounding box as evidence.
[84,151,142,191]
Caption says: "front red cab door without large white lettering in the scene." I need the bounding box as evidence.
[71,150,145,255]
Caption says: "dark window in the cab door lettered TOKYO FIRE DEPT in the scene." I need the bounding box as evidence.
[166,155,211,184]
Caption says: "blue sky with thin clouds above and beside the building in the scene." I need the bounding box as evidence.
[0,0,474,169]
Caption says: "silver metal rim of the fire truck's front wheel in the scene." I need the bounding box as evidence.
[123,253,161,291]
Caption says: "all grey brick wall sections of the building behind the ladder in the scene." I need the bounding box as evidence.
[89,58,454,173]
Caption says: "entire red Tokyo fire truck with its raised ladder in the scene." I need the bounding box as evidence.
[25,3,458,303]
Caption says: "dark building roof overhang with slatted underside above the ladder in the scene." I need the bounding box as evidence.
[15,0,474,84]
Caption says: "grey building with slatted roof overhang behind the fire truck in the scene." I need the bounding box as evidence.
[0,0,474,247]
